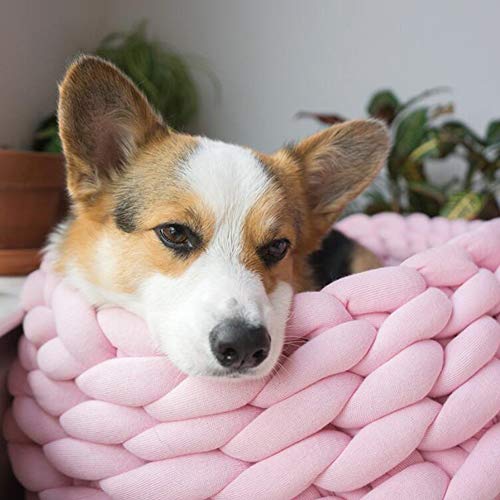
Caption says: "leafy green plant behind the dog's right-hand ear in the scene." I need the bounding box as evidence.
[300,87,500,219]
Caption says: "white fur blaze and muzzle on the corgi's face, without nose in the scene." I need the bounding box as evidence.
[49,139,293,377]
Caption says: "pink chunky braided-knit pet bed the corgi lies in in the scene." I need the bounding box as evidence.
[4,214,500,500]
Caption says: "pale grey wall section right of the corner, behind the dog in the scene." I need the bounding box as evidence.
[104,0,500,150]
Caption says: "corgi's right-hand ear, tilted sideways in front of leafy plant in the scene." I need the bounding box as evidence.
[292,120,390,231]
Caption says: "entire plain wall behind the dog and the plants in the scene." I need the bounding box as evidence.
[0,0,500,151]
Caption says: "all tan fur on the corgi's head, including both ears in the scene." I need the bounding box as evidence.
[57,57,389,302]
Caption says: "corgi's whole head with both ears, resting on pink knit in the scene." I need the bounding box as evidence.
[53,57,388,377]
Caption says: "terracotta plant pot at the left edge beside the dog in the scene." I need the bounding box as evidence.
[0,150,67,276]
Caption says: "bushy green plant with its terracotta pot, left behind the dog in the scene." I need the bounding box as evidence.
[0,23,198,275]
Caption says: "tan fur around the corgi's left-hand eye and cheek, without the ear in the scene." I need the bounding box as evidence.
[57,134,215,293]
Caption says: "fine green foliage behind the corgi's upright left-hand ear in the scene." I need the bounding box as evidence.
[33,22,198,152]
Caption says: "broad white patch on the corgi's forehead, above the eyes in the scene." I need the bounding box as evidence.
[181,138,272,223]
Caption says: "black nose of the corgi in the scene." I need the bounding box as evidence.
[210,319,271,368]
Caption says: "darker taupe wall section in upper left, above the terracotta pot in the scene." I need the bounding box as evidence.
[0,0,108,148]
